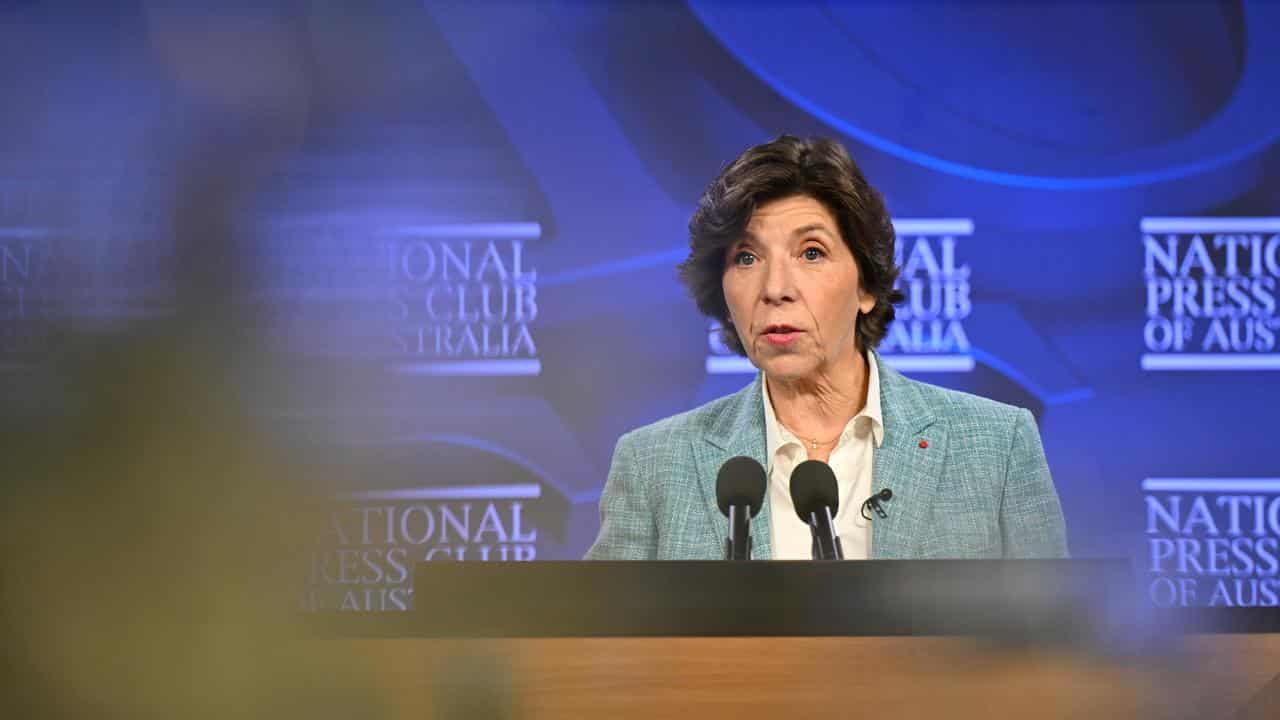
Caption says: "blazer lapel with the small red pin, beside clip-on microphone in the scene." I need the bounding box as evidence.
[869,352,947,560]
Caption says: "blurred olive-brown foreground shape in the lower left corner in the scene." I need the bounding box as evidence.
[0,329,376,719]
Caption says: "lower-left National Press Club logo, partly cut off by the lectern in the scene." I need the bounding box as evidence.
[302,483,541,611]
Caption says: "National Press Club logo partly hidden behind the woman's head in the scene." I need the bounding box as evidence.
[707,218,974,374]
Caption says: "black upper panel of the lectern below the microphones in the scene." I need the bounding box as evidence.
[401,560,1137,638]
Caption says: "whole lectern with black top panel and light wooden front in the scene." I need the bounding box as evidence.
[321,560,1280,720]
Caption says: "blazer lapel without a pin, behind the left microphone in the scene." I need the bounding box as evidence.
[692,373,773,560]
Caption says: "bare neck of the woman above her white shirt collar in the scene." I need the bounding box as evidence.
[764,351,870,443]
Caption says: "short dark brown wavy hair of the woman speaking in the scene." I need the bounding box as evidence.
[678,135,904,355]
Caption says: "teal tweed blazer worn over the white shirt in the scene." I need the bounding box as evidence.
[586,352,1068,560]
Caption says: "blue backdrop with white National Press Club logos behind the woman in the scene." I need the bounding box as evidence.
[0,0,1280,610]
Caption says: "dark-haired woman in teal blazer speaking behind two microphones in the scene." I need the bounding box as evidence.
[586,136,1066,560]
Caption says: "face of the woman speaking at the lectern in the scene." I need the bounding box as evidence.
[722,195,876,380]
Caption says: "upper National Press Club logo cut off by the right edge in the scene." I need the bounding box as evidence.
[1142,218,1280,370]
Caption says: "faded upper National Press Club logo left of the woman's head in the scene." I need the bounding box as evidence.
[387,223,541,375]
